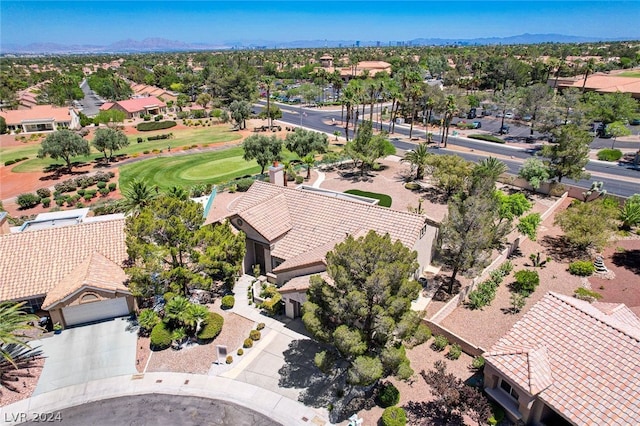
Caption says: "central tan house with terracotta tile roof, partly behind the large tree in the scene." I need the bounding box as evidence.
[222,166,438,318]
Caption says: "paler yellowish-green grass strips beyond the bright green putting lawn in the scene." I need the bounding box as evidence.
[0,125,241,173]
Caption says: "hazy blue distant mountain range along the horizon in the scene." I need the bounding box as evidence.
[0,34,636,55]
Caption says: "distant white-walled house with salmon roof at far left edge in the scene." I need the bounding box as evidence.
[0,105,80,133]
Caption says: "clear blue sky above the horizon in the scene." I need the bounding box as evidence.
[0,0,640,45]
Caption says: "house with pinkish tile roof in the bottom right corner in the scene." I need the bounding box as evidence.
[483,292,640,426]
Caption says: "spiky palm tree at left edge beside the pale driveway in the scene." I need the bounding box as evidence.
[0,302,38,371]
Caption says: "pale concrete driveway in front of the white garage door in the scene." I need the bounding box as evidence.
[32,318,137,395]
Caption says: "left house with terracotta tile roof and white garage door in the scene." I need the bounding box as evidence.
[0,219,135,327]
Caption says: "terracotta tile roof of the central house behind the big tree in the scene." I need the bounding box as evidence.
[230,181,426,261]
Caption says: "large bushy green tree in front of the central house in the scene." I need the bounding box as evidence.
[302,231,426,386]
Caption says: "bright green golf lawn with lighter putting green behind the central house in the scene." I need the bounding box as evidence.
[119,146,295,189]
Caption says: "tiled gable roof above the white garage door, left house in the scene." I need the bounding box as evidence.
[42,251,131,310]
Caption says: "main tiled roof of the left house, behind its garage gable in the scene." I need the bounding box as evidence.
[0,219,127,301]
